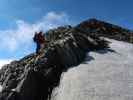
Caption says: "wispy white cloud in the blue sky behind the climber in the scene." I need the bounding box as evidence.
[0,12,70,52]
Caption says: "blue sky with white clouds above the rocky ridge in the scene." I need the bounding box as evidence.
[0,0,133,66]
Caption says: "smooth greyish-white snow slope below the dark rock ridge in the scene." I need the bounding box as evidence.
[51,40,133,100]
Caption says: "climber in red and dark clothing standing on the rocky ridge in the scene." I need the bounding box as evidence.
[33,31,45,54]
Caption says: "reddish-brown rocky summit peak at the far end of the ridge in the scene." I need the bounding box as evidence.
[76,19,133,43]
